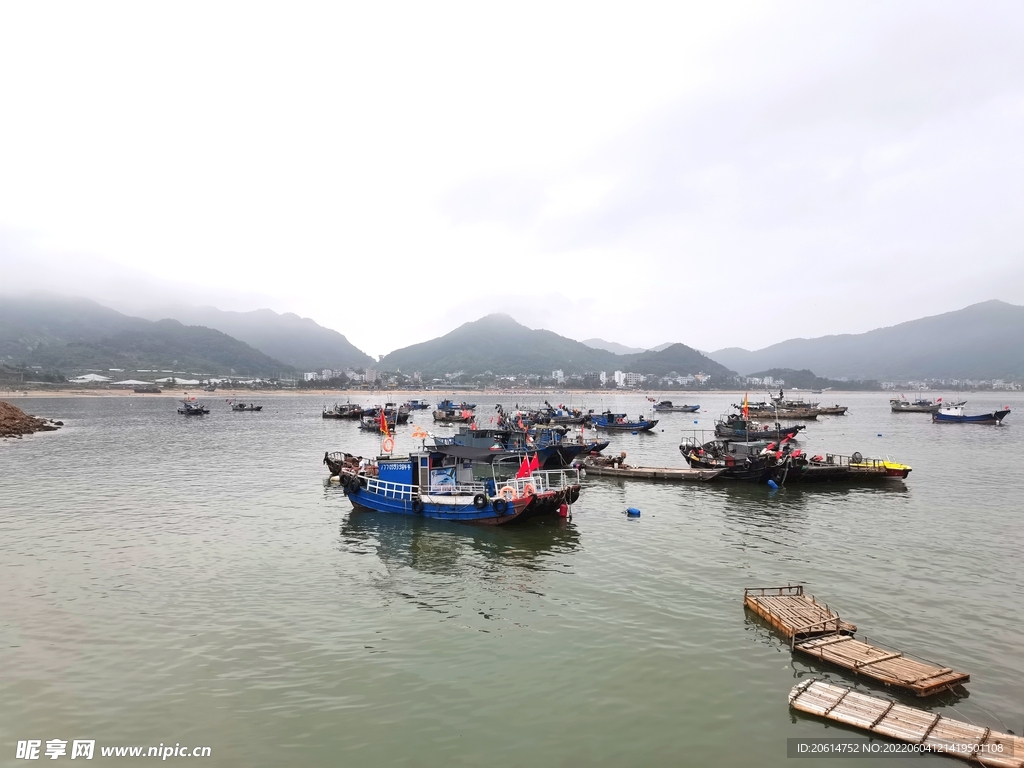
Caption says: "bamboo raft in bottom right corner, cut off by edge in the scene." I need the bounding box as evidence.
[790,680,1024,768]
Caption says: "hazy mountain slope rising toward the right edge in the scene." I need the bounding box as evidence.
[710,301,1024,381]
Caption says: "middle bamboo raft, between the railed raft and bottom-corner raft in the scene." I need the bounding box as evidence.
[792,634,971,696]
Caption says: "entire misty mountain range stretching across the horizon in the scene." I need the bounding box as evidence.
[0,295,1024,382]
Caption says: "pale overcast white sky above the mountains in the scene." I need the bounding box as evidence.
[0,0,1024,354]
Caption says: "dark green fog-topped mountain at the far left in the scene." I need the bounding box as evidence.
[0,296,290,376]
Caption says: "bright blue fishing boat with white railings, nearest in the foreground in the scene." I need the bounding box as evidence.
[325,447,579,525]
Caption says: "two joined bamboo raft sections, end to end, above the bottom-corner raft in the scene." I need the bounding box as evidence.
[743,586,971,696]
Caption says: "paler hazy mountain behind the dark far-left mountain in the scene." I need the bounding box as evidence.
[138,305,374,371]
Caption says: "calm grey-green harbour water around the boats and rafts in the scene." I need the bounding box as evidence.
[0,393,1024,766]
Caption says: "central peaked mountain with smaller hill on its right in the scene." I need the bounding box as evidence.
[379,314,732,377]
